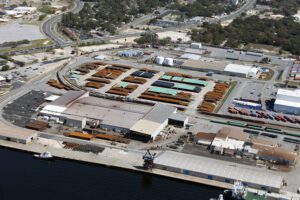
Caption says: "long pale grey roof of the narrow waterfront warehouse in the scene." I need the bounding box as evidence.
[154,151,283,189]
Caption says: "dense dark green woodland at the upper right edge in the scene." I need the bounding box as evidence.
[190,16,300,55]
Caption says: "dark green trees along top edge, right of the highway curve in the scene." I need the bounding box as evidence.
[62,0,173,34]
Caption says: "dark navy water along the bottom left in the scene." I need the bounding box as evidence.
[0,148,222,200]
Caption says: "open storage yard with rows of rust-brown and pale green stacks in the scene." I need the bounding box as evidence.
[68,62,215,109]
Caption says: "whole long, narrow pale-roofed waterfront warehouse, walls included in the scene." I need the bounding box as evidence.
[154,151,283,192]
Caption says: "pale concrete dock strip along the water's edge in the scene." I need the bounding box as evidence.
[0,140,300,199]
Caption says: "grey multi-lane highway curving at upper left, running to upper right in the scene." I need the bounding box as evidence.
[42,0,256,47]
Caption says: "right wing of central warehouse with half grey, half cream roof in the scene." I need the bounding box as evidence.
[130,103,177,141]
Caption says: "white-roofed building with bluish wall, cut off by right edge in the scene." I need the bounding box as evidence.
[274,89,300,115]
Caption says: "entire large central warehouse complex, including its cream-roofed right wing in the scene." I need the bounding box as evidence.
[40,91,188,140]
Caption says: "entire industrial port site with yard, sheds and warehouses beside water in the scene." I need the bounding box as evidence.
[3,36,300,200]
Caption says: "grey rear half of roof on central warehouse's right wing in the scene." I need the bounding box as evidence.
[143,103,177,123]
